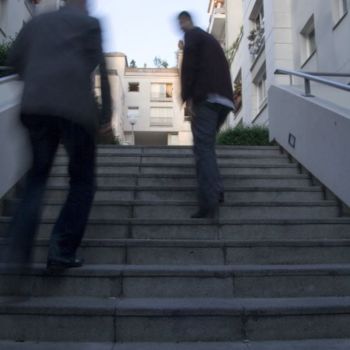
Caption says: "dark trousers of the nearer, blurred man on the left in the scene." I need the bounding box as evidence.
[6,115,95,265]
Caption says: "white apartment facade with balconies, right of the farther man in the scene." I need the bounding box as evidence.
[209,0,350,127]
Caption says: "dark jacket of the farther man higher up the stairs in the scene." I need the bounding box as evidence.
[181,27,233,103]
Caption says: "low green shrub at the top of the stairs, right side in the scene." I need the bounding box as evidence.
[217,126,271,146]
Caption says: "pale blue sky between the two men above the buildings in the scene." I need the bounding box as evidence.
[90,0,209,67]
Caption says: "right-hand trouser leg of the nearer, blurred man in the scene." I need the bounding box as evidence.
[49,121,96,259]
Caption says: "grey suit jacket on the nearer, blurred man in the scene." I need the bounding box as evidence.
[8,6,112,132]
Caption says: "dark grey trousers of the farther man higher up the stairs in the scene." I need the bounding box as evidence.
[191,102,230,211]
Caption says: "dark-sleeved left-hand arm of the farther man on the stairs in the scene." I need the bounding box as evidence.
[181,30,200,102]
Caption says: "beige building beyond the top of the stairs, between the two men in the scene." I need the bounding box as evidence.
[96,53,192,145]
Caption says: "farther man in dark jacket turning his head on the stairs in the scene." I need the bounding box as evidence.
[178,12,234,218]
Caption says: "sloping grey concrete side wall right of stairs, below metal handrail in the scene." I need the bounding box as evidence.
[269,86,350,205]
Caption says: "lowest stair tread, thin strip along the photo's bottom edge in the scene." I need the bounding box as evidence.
[0,339,350,350]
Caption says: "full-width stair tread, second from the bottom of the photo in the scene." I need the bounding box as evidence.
[0,297,350,317]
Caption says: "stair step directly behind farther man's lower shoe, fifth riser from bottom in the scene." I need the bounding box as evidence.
[31,200,339,220]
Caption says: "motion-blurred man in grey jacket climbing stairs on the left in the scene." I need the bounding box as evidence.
[6,0,111,270]
